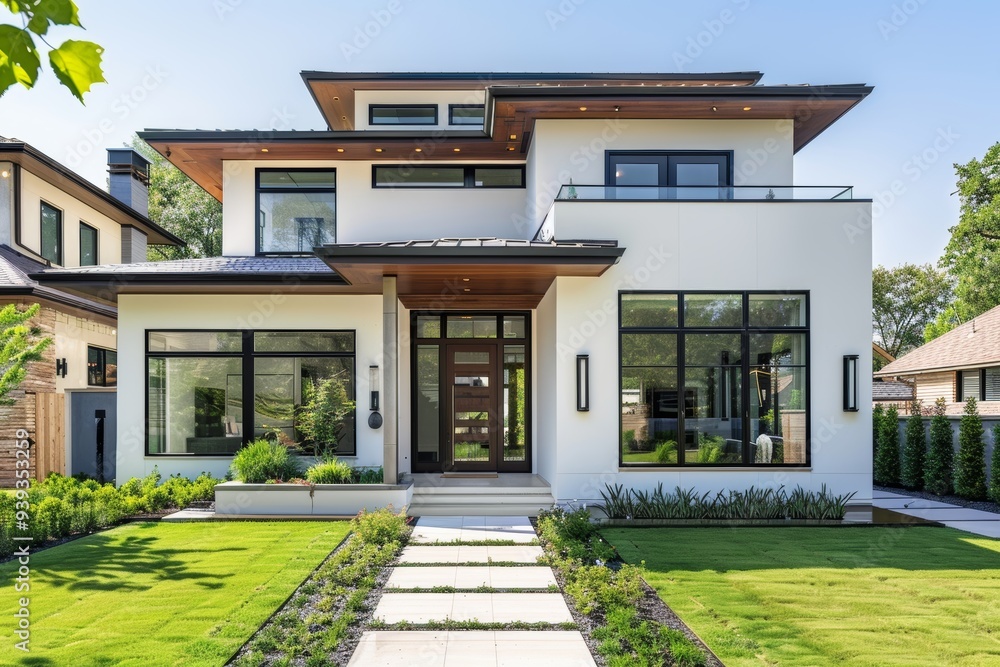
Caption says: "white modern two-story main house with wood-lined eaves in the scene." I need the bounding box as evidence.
[33,72,872,511]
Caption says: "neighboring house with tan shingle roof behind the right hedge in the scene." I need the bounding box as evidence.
[875,306,1000,415]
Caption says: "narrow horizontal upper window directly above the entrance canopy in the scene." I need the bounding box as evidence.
[372,164,524,188]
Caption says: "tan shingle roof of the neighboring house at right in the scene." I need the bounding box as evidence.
[876,306,1000,377]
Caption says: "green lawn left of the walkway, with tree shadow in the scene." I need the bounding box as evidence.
[0,521,349,667]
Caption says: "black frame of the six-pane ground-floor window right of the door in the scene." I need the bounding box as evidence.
[616,289,812,470]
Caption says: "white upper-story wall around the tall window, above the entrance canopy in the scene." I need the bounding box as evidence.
[222,160,525,256]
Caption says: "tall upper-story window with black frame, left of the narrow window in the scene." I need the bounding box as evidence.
[257,169,337,254]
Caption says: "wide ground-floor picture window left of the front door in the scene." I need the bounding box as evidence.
[146,331,356,456]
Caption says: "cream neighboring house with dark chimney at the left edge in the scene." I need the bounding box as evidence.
[0,138,183,487]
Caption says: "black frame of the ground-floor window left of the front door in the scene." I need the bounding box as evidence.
[143,328,360,458]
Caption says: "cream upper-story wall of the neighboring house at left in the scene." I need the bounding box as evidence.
[20,169,122,268]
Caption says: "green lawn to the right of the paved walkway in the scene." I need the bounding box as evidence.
[602,527,1000,667]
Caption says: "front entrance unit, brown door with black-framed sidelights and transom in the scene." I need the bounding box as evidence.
[411,312,531,472]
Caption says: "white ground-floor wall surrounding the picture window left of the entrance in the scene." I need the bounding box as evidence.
[117,292,382,481]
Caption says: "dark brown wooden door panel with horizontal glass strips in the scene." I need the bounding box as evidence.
[443,345,501,470]
